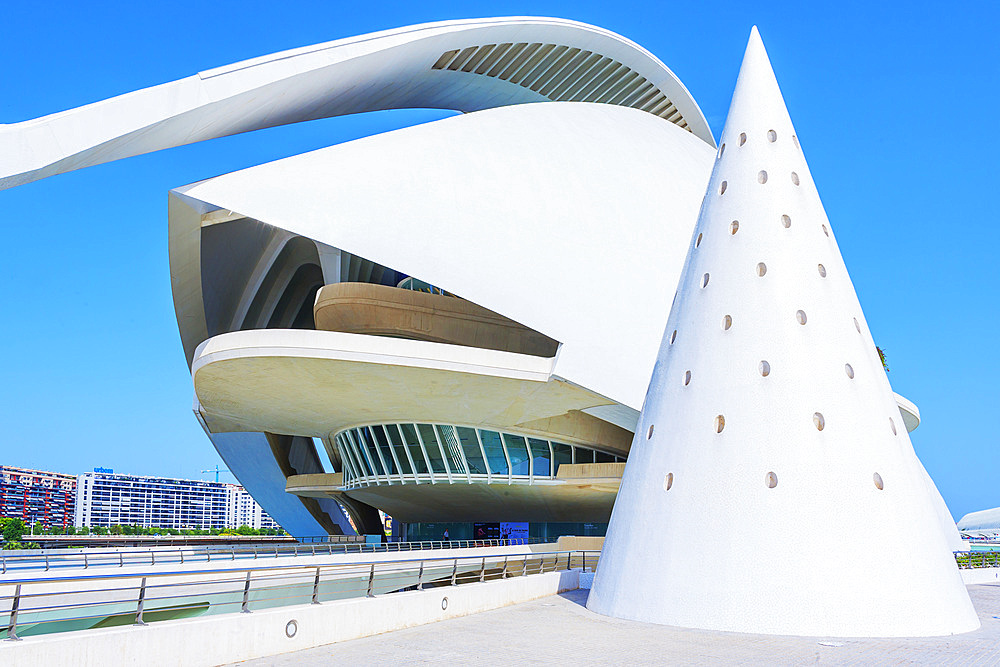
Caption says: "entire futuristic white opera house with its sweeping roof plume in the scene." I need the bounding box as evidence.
[0,17,936,548]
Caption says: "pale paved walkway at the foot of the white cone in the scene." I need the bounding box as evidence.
[230,584,1000,666]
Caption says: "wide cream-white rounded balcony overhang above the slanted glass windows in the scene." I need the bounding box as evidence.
[191,329,632,456]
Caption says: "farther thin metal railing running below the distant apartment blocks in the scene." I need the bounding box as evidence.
[0,538,544,574]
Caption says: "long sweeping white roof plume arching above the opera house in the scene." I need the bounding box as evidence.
[0,17,715,190]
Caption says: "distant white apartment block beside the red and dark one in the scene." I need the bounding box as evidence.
[75,472,277,530]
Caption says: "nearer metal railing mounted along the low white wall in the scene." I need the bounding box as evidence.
[0,550,600,641]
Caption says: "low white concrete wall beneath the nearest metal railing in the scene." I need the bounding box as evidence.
[0,570,579,667]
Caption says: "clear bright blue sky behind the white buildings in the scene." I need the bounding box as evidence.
[0,0,1000,517]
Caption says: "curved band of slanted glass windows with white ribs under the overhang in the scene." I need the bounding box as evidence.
[334,424,625,487]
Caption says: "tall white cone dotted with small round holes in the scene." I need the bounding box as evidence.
[587,29,979,636]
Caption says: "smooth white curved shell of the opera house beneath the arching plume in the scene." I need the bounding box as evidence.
[170,102,714,412]
